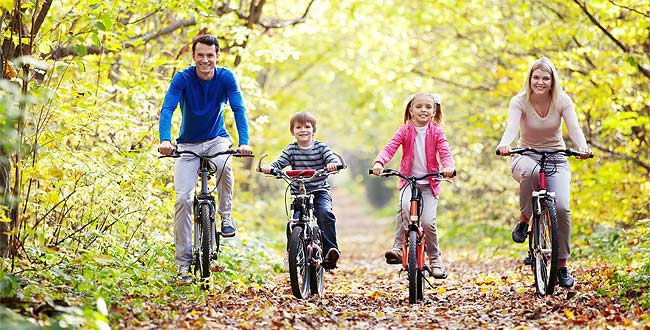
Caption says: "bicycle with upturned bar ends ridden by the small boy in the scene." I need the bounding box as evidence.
[257,152,347,299]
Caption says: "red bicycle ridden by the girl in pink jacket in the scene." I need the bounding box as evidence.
[368,168,456,304]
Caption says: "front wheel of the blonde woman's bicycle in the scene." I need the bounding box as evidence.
[533,199,560,295]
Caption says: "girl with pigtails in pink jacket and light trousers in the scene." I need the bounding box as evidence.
[372,93,454,279]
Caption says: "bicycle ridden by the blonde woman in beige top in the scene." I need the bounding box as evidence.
[496,148,594,295]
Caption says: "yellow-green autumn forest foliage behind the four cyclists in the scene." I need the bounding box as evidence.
[0,0,650,324]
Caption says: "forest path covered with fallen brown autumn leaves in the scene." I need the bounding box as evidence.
[113,192,650,329]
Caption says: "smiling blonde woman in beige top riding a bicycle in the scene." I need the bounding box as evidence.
[497,57,591,287]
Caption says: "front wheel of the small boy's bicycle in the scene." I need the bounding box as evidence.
[289,226,309,299]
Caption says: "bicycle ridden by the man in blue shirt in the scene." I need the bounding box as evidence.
[158,149,254,283]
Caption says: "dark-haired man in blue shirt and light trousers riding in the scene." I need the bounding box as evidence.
[158,35,252,283]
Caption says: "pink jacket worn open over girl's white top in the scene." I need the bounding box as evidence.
[375,122,455,198]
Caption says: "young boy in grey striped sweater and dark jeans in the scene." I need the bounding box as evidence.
[262,112,341,269]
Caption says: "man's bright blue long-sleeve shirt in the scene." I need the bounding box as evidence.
[158,66,248,145]
